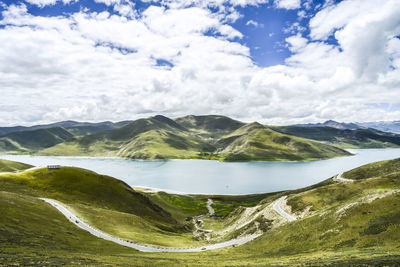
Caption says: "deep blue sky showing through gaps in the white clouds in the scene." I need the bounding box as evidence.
[0,0,339,67]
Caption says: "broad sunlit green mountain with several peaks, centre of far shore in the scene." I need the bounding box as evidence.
[40,115,350,161]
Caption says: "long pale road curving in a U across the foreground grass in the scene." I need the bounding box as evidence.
[40,198,261,252]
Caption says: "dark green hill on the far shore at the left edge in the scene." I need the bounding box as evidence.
[0,127,73,152]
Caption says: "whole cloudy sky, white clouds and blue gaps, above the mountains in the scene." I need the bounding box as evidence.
[0,0,400,126]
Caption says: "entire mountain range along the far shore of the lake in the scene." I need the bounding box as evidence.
[0,115,400,161]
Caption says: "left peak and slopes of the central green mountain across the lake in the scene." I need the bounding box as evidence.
[40,116,215,159]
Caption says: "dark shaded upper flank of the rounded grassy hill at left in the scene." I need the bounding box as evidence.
[0,167,174,222]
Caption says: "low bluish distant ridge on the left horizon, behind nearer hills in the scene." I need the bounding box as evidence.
[0,121,131,136]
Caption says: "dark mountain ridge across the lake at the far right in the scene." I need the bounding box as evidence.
[270,126,400,148]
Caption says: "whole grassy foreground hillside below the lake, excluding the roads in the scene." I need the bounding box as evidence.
[0,159,400,266]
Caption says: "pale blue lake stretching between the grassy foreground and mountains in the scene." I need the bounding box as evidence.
[0,148,400,194]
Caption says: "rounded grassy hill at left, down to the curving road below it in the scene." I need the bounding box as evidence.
[0,162,201,246]
